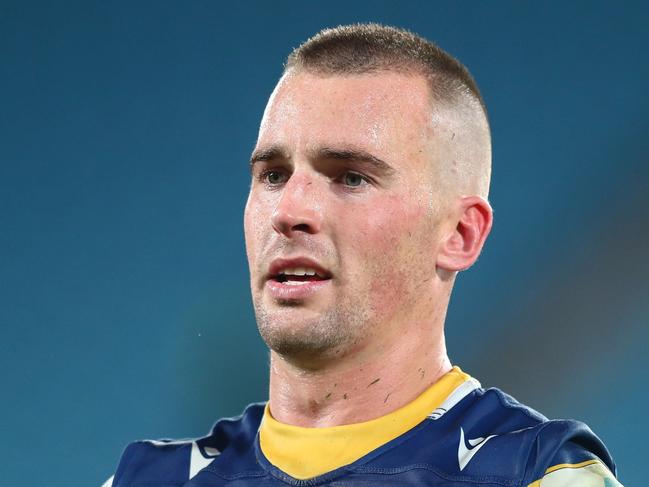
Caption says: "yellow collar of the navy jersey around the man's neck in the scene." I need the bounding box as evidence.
[259,367,470,479]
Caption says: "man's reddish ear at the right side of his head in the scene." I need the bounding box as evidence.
[437,196,493,271]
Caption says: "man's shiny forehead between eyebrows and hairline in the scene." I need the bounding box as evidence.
[257,72,432,164]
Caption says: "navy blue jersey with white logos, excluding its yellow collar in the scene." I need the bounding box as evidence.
[106,379,620,487]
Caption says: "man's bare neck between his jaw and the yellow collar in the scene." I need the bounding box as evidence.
[269,325,451,427]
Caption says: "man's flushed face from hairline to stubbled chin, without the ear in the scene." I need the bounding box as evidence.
[245,72,450,358]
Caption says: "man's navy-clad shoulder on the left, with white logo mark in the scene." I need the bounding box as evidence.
[109,403,264,487]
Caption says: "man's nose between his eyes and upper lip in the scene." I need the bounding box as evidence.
[271,174,322,237]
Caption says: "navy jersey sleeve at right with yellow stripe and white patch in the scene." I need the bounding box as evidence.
[524,421,622,487]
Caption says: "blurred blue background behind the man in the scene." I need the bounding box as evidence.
[0,0,649,486]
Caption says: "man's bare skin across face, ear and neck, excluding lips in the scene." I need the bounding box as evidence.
[244,71,491,426]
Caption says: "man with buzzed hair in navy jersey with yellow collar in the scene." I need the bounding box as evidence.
[104,24,619,487]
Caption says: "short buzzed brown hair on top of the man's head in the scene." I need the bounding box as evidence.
[284,23,487,116]
